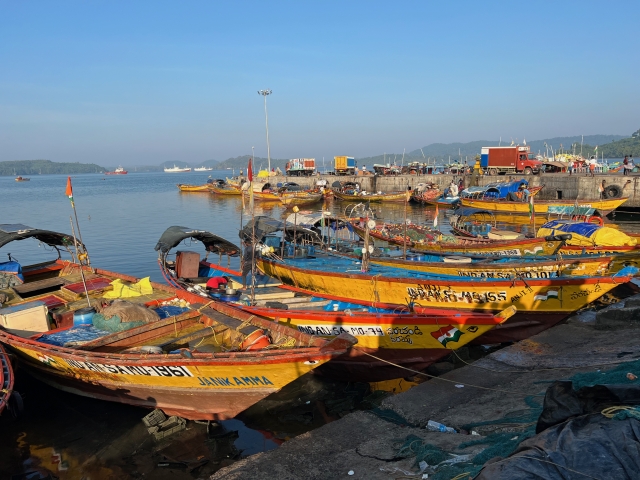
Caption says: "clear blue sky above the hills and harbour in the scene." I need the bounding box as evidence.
[0,0,640,165]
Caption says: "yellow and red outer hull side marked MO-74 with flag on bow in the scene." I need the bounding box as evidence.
[234,307,515,382]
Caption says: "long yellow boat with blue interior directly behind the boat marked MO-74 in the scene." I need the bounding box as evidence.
[258,254,637,343]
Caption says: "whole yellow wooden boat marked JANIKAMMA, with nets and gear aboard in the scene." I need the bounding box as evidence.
[0,225,355,420]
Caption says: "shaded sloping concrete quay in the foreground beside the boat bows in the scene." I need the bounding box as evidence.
[211,295,640,480]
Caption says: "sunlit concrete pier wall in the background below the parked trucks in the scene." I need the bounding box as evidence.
[254,173,640,210]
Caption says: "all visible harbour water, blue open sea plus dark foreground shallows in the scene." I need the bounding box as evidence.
[0,171,640,479]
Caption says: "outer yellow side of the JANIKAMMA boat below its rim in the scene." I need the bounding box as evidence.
[9,342,331,420]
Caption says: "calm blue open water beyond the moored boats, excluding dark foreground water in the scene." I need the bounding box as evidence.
[0,171,436,282]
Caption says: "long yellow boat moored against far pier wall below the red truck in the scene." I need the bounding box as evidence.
[460,197,629,215]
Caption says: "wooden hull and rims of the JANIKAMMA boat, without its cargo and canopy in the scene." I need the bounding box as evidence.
[0,260,355,420]
